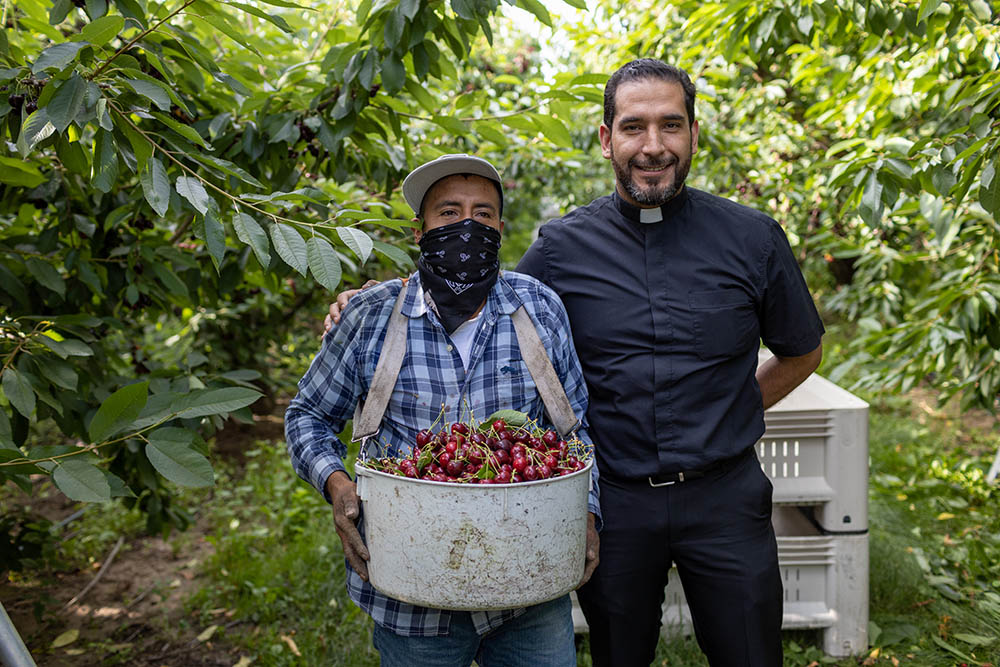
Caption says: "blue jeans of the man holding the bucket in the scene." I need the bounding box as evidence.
[372,595,576,667]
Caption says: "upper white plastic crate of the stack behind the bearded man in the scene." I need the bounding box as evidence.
[755,351,868,532]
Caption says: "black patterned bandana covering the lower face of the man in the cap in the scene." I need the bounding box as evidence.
[417,218,500,333]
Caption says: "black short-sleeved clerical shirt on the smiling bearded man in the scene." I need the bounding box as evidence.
[517,186,823,478]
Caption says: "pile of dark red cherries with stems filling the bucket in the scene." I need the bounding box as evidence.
[357,419,591,484]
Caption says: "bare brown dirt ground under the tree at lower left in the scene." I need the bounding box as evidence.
[0,415,284,667]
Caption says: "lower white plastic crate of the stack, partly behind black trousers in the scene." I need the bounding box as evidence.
[573,507,868,657]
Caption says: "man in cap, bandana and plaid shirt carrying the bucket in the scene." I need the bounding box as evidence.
[285,155,600,667]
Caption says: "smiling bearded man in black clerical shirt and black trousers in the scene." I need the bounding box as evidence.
[330,58,824,667]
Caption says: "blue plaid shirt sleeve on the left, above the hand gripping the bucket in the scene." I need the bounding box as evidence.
[285,290,391,502]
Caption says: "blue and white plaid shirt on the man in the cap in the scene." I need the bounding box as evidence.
[285,271,601,637]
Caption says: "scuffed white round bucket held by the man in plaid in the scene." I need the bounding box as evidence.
[355,461,593,610]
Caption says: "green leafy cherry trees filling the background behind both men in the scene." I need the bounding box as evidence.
[0,0,1000,530]
